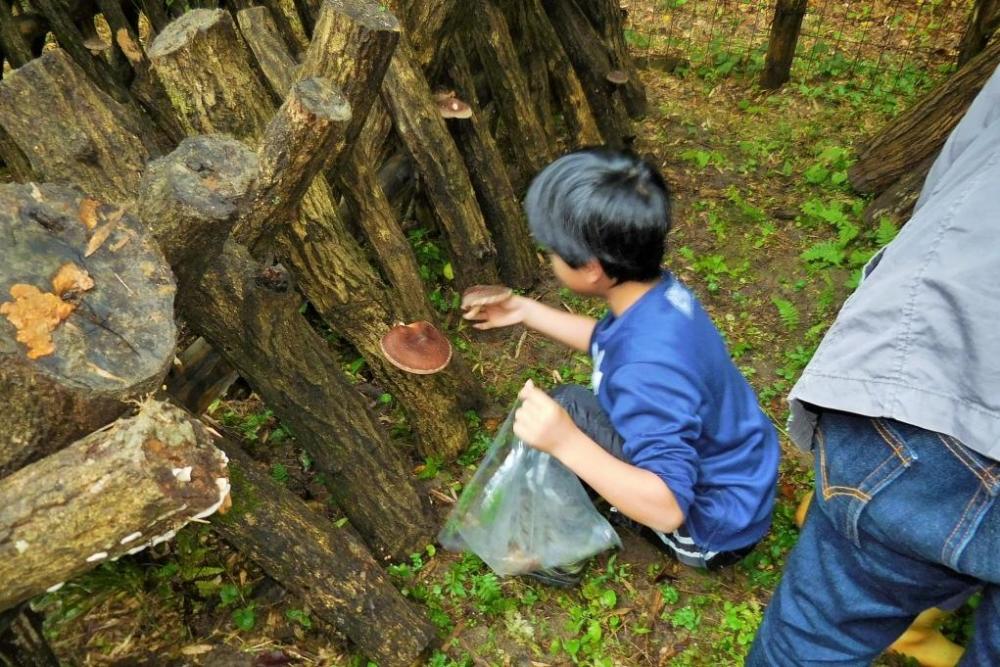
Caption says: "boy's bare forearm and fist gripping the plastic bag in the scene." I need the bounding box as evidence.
[514,380,684,533]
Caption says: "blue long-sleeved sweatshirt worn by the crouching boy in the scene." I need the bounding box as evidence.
[590,273,780,551]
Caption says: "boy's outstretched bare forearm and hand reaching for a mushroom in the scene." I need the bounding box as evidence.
[463,295,597,352]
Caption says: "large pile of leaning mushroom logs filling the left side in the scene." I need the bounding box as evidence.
[0,0,645,665]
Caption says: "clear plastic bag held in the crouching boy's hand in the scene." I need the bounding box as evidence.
[438,404,621,575]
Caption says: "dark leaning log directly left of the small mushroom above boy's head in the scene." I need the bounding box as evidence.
[542,0,633,147]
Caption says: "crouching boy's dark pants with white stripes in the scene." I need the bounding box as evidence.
[551,384,753,570]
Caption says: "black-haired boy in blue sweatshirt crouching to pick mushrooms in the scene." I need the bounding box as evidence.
[466,149,779,585]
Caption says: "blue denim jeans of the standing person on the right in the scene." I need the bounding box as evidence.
[746,412,1000,667]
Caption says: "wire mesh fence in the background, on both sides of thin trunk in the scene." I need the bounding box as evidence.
[622,0,971,89]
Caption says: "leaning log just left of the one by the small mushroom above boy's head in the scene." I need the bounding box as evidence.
[504,0,604,148]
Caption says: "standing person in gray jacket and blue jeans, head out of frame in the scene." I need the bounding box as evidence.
[746,65,1000,667]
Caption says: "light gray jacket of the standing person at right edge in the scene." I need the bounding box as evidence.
[789,68,1000,461]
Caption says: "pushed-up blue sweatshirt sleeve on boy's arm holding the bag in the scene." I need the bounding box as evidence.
[605,362,703,518]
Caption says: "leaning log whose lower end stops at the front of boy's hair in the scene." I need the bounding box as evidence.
[467,0,555,190]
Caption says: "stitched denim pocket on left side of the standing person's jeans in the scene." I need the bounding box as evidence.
[815,414,917,546]
